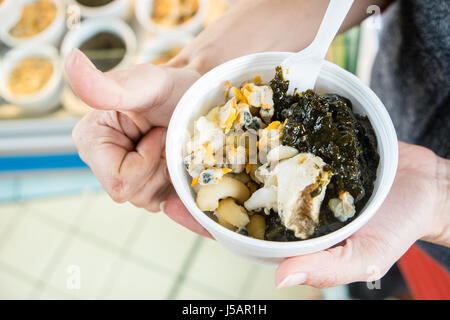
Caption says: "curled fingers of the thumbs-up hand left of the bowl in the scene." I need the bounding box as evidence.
[73,112,168,202]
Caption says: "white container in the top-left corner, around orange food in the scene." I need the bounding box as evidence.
[0,0,66,47]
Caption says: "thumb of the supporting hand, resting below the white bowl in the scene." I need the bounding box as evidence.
[275,238,396,288]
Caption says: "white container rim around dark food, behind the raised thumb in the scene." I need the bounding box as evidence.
[61,18,136,69]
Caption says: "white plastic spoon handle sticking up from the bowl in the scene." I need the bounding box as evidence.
[308,0,354,59]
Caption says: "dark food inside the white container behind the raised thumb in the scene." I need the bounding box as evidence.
[80,32,126,72]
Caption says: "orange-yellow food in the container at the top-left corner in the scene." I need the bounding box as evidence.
[9,0,57,38]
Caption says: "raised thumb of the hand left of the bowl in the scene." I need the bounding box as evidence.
[65,49,171,112]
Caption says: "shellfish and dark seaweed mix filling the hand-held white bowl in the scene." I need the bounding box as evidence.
[184,67,379,241]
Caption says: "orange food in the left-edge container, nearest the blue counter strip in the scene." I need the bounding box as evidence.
[8,57,54,95]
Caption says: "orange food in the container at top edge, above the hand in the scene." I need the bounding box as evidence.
[151,0,199,27]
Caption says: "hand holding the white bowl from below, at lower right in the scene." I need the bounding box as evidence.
[165,142,450,288]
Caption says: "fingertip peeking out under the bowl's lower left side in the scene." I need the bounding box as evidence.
[162,197,214,239]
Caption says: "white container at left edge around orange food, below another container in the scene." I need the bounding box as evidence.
[0,45,62,114]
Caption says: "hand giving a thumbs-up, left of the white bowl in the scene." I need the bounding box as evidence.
[65,50,200,212]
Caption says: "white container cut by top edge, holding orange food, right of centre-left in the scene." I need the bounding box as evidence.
[134,0,208,35]
